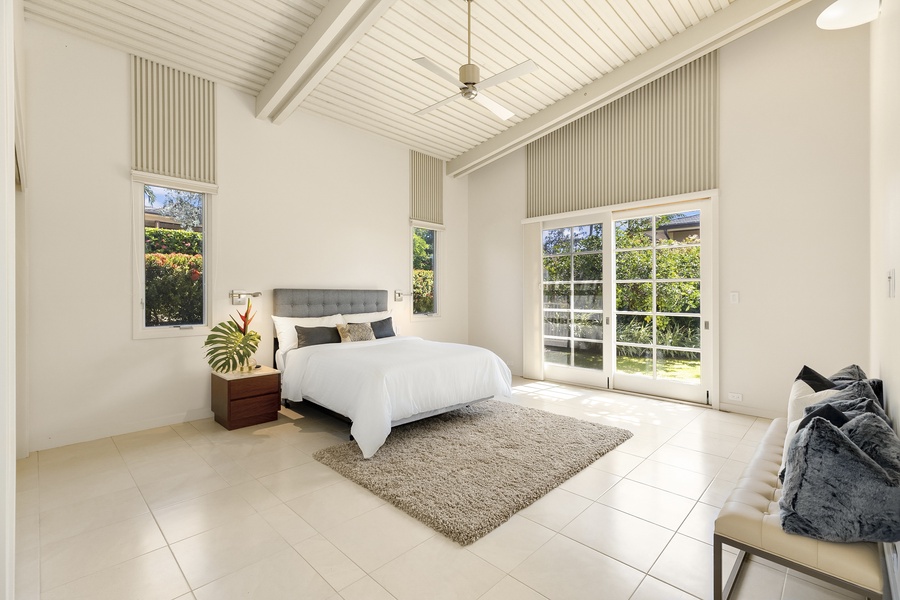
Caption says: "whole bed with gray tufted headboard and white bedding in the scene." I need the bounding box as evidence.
[273,289,512,458]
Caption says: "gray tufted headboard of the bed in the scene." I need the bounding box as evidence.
[272,289,388,317]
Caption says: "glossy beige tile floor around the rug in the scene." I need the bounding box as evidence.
[10,379,860,600]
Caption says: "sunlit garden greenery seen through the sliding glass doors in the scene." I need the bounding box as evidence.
[543,214,700,379]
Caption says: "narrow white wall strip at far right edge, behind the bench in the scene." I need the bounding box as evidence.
[871,0,900,431]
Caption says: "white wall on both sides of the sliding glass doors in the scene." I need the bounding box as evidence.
[469,0,869,416]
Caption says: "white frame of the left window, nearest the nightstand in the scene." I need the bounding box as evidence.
[131,171,219,340]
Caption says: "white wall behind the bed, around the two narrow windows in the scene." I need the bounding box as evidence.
[25,21,468,450]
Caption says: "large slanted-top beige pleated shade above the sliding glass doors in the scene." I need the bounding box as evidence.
[527,52,719,217]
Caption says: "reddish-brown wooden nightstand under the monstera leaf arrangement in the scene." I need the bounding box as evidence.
[211,367,281,430]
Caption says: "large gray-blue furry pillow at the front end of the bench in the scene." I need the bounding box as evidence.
[779,418,900,542]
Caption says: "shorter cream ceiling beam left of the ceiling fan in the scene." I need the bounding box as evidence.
[256,0,396,123]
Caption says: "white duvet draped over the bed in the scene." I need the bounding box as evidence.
[282,336,512,458]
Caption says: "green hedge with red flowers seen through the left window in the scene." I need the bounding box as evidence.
[144,254,203,327]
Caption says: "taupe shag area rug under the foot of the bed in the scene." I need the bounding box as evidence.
[313,400,632,545]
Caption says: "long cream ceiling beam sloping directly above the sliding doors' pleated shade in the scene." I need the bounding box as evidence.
[447,0,810,177]
